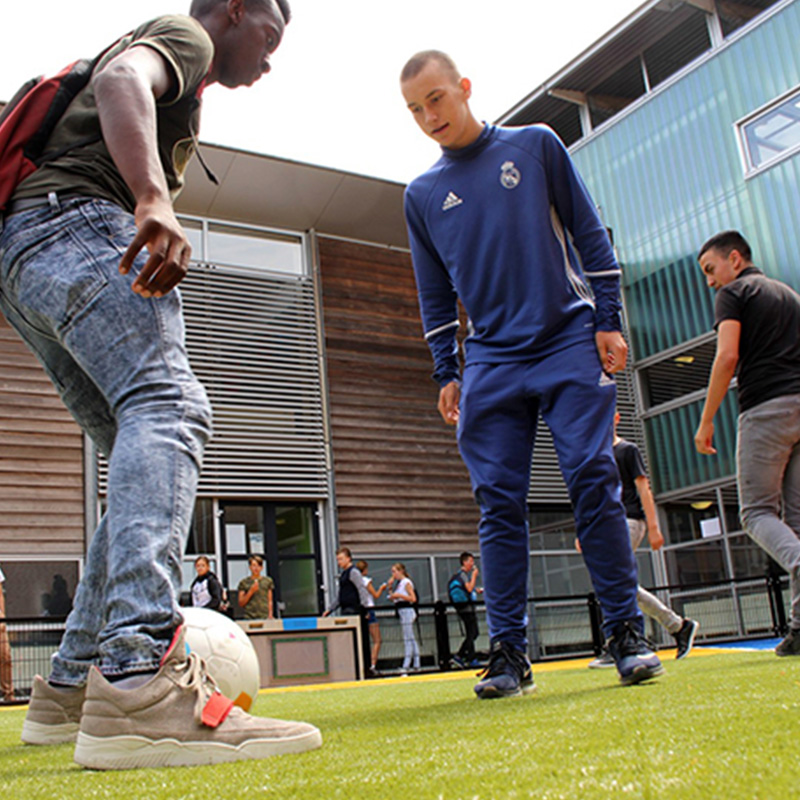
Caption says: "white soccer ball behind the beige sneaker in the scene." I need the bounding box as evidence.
[181,607,260,711]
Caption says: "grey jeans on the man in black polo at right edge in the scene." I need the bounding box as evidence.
[736,394,800,630]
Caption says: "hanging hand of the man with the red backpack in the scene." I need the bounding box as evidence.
[119,198,192,297]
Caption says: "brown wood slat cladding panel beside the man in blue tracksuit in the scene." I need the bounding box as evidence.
[318,237,479,555]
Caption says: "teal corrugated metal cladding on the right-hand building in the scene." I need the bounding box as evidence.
[572,0,800,492]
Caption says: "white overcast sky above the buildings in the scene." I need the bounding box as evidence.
[0,0,641,183]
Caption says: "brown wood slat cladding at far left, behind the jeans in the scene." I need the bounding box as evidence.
[0,314,84,557]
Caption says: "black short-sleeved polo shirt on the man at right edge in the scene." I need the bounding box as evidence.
[714,267,800,411]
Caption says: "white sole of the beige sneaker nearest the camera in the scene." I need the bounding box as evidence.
[75,728,322,769]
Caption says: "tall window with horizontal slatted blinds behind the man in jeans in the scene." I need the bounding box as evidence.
[99,219,328,499]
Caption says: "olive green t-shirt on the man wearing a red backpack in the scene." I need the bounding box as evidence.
[13,15,214,212]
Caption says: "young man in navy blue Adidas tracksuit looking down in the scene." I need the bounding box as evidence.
[401,51,663,698]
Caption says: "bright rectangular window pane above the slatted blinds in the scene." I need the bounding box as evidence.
[206,224,303,275]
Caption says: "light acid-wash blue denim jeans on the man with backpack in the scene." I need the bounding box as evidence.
[0,198,211,686]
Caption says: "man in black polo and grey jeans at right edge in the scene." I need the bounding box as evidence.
[694,231,800,656]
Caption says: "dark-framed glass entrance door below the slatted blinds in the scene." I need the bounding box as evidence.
[220,502,323,617]
